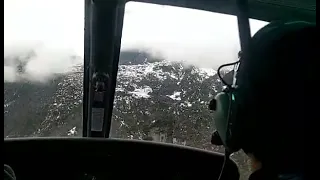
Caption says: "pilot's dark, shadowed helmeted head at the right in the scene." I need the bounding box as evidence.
[237,22,317,172]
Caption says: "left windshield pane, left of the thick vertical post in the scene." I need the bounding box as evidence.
[4,0,84,138]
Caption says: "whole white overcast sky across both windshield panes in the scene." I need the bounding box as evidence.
[4,0,266,81]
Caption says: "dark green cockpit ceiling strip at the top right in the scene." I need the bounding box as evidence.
[136,0,316,22]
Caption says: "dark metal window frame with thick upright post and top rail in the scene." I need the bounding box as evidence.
[83,0,316,138]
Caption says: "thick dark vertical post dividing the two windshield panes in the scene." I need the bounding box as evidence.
[83,0,125,138]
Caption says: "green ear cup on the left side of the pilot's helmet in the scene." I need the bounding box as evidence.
[213,92,230,148]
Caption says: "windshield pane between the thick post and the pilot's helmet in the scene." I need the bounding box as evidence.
[111,2,266,178]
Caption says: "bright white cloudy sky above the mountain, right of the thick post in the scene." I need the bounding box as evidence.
[122,2,266,68]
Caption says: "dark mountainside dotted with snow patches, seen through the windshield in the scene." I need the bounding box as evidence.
[4,51,230,139]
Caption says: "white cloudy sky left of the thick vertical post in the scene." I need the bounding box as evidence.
[4,0,84,82]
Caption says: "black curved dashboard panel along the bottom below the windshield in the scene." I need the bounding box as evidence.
[4,138,239,180]
